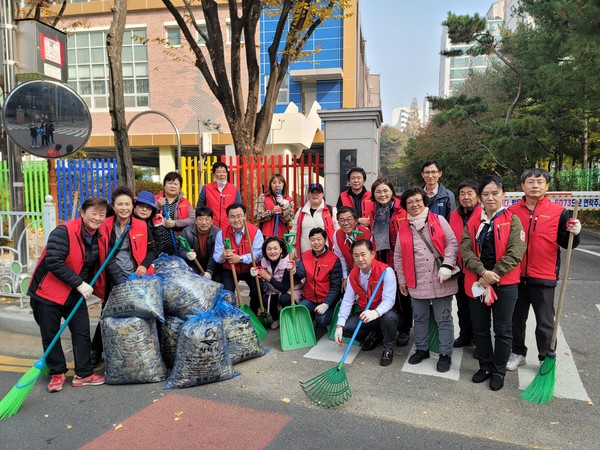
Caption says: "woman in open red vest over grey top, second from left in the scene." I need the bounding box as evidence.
[92,186,157,367]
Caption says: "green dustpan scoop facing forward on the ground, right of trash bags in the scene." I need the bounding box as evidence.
[279,305,317,352]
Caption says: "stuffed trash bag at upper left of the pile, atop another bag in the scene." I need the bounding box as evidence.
[102,275,165,322]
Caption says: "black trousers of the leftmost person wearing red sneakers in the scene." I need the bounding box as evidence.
[30,296,94,378]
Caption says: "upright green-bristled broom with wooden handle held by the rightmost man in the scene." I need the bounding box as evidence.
[520,200,579,405]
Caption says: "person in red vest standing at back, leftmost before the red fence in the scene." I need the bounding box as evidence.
[196,161,242,230]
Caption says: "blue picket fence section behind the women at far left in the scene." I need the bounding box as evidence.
[56,158,117,221]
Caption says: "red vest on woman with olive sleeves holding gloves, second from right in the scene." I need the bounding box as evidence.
[463,209,521,297]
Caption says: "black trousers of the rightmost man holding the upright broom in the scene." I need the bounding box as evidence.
[512,283,556,361]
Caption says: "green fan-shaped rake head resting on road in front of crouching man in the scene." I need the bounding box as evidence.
[300,364,352,408]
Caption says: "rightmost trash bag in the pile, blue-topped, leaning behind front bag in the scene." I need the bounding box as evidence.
[215,301,266,364]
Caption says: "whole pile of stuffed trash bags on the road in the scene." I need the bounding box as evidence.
[100,255,265,389]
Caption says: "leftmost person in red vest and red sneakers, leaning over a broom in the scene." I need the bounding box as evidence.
[27,198,108,392]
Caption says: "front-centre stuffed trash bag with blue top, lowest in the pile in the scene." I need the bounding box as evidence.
[165,311,237,389]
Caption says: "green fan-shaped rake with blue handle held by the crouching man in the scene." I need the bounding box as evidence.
[300,270,385,408]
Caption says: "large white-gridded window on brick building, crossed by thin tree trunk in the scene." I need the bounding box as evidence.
[67,28,150,109]
